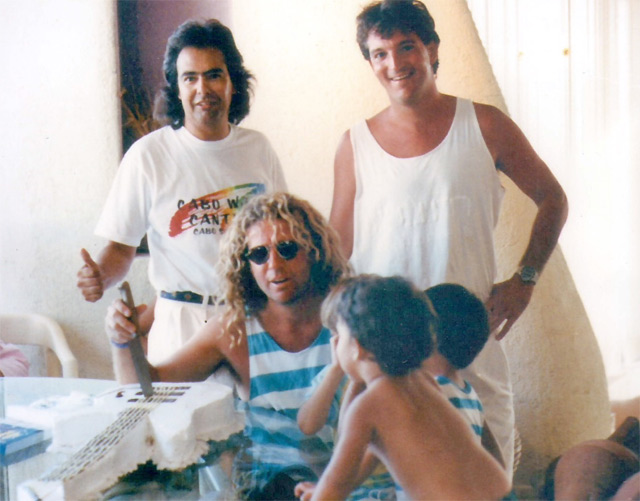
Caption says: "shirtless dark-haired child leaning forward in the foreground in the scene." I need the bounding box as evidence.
[312,275,511,500]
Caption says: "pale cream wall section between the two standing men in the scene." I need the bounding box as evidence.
[232,0,386,216]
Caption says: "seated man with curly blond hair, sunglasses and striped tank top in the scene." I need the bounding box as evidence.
[106,193,348,492]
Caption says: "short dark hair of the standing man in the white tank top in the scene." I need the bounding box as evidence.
[356,0,440,73]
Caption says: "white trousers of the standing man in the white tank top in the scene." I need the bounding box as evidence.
[461,334,515,480]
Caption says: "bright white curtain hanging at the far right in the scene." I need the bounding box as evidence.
[467,0,640,385]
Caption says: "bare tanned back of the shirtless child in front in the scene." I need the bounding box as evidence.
[360,371,510,500]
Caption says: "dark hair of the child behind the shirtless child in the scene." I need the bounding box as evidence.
[425,284,489,369]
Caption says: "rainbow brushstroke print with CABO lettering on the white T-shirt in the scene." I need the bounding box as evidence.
[169,183,265,237]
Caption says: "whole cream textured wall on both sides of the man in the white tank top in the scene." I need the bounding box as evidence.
[233,0,611,481]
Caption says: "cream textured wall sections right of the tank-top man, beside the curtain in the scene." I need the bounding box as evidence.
[427,0,611,479]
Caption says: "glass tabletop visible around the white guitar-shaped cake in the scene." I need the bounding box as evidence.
[0,378,333,500]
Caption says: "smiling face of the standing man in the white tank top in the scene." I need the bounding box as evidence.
[367,31,438,104]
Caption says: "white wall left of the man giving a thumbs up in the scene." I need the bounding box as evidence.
[0,0,152,377]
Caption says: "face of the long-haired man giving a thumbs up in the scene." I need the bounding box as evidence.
[176,47,233,141]
